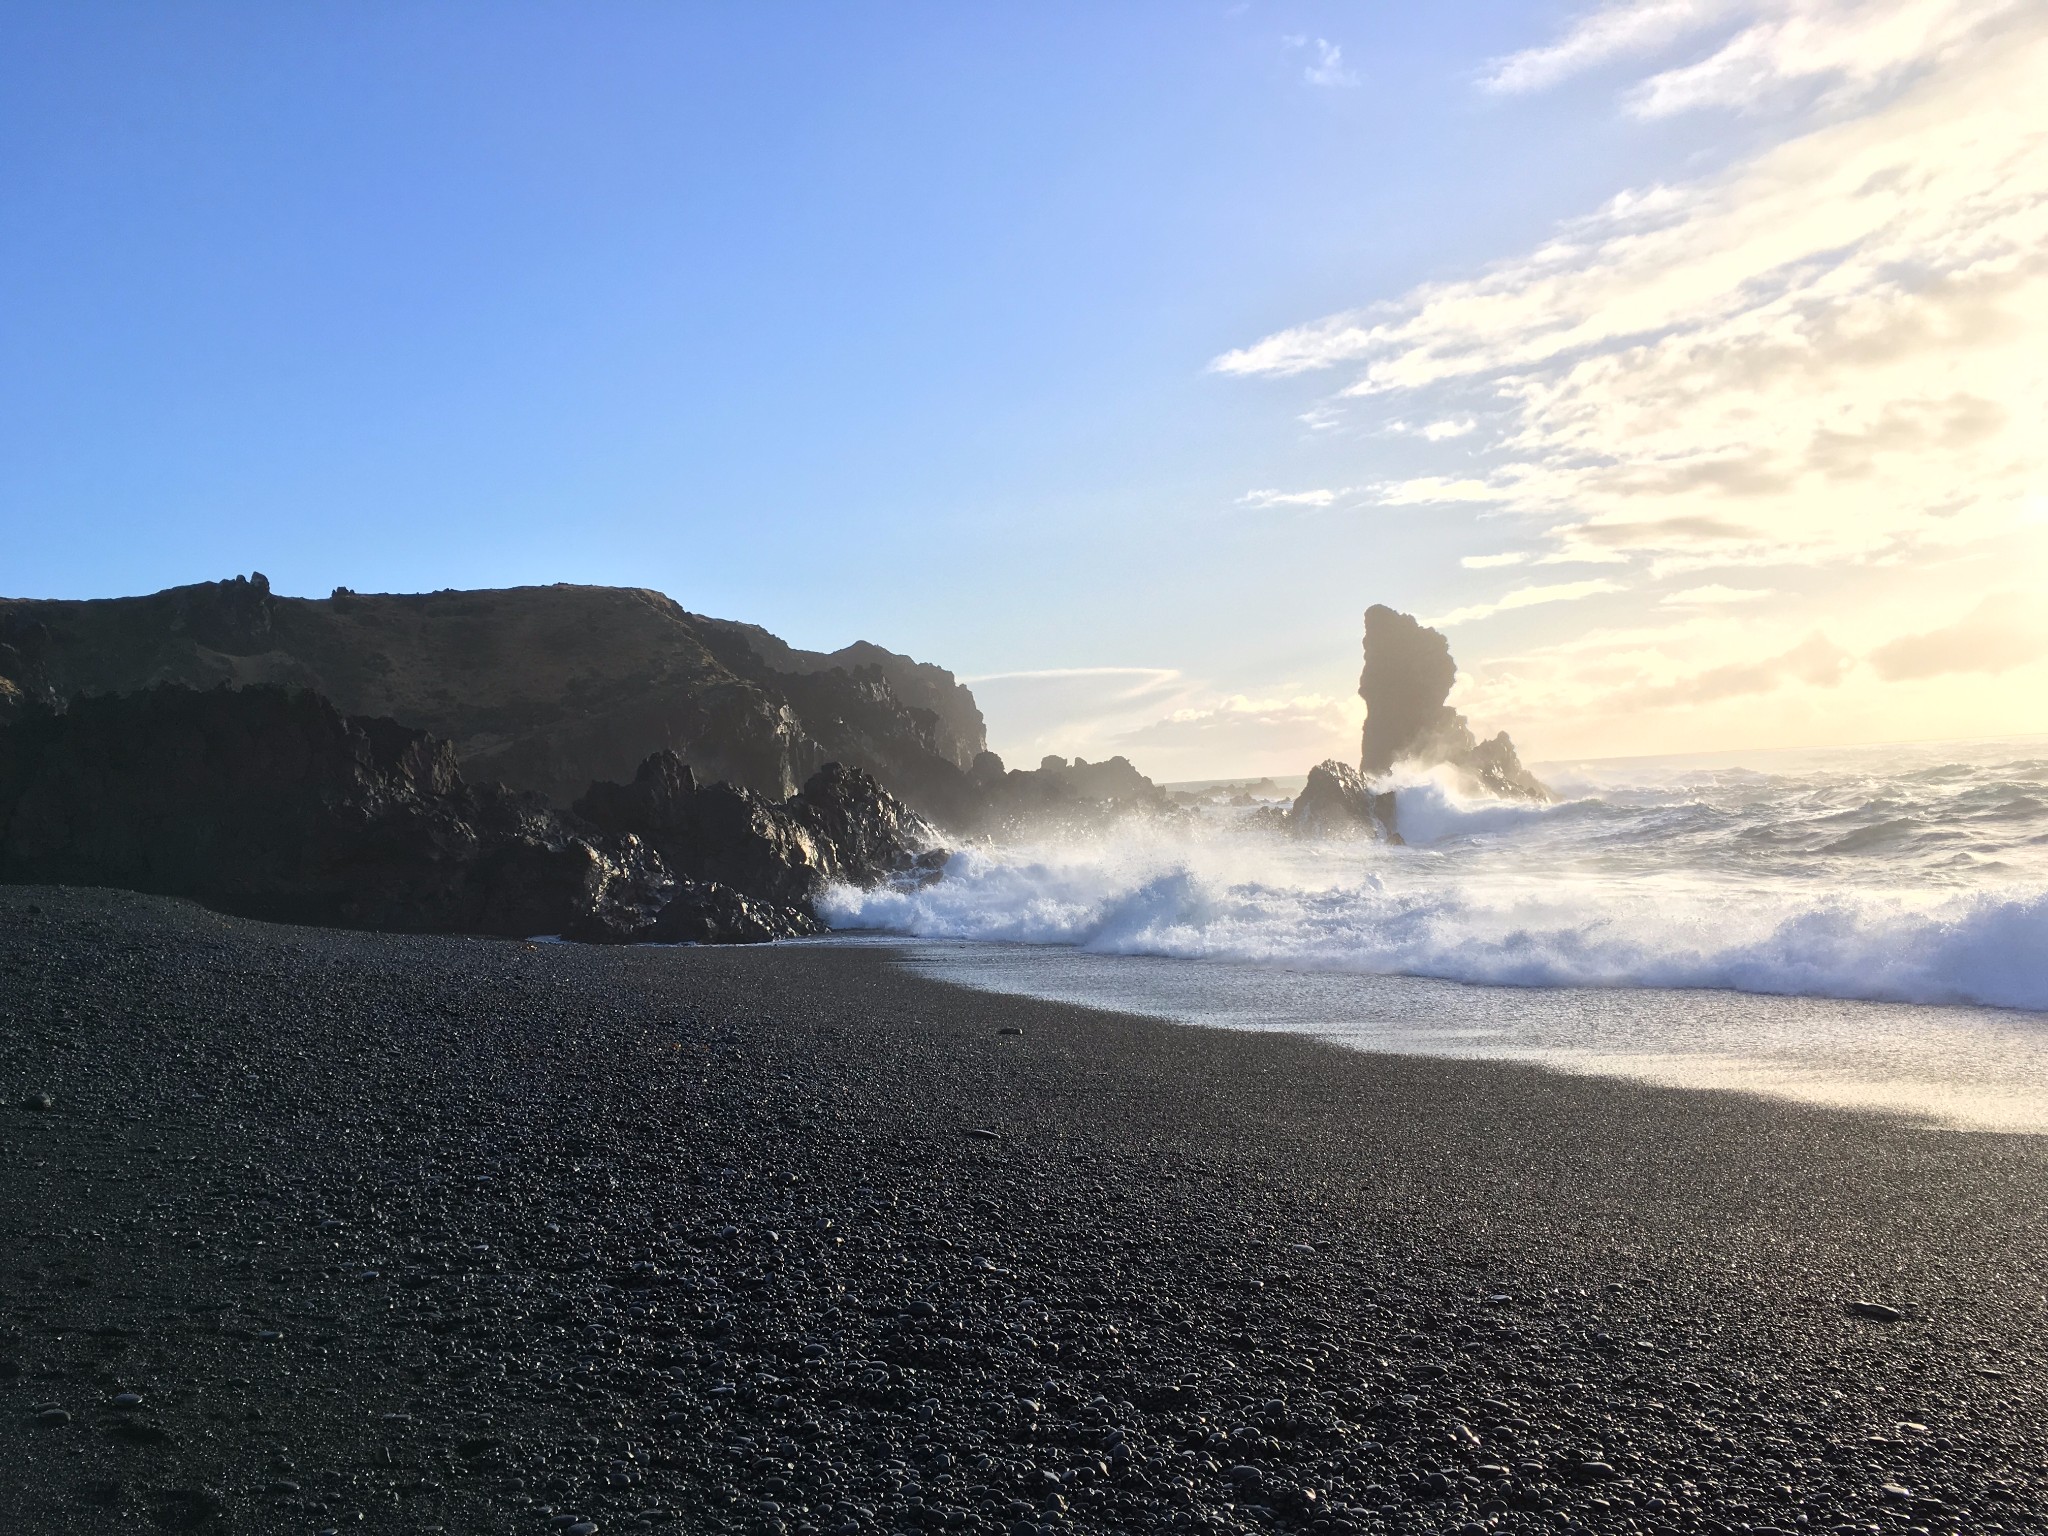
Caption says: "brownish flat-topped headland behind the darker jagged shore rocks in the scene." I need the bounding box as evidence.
[0,573,985,825]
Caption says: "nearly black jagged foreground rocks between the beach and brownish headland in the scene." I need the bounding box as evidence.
[0,684,936,942]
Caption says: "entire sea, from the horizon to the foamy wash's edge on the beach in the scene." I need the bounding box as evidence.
[823,741,2048,1133]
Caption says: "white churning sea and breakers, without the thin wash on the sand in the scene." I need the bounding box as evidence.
[823,752,2048,1024]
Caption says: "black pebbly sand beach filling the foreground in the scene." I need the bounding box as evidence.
[0,889,2048,1532]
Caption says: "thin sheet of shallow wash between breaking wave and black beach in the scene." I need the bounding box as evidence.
[872,934,2048,1135]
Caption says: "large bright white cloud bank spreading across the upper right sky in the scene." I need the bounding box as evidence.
[1212,0,2048,573]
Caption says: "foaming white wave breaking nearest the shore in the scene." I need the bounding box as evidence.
[823,840,2048,1010]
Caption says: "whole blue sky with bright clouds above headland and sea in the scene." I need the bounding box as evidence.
[0,0,2048,780]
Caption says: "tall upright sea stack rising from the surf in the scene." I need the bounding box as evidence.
[1358,604,1550,801]
